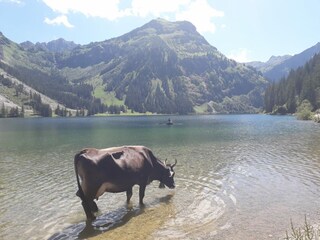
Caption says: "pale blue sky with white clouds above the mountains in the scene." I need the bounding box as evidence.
[0,0,320,62]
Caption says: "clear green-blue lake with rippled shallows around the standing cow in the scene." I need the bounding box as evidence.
[0,115,320,240]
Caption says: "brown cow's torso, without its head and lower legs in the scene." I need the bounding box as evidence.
[76,146,153,198]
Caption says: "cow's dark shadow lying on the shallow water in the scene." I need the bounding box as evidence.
[49,195,173,240]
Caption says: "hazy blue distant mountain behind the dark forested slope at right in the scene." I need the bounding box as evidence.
[247,42,320,81]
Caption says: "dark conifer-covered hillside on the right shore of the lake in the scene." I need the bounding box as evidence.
[265,54,320,114]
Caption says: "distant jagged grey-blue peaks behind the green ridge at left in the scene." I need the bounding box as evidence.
[20,38,80,52]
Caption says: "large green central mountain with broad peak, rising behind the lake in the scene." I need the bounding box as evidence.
[0,19,267,114]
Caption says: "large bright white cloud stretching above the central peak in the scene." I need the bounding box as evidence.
[42,0,224,33]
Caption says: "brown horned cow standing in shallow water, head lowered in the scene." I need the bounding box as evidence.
[74,146,177,221]
